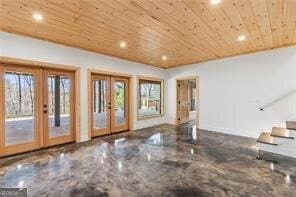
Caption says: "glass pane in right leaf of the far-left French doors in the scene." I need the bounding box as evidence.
[48,75,71,138]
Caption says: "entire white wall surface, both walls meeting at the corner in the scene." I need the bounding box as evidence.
[0,32,296,141]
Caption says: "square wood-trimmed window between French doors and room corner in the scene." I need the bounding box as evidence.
[138,78,163,118]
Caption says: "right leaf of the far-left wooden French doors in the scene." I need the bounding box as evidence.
[43,70,75,146]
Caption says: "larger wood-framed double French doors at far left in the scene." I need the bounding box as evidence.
[0,65,75,156]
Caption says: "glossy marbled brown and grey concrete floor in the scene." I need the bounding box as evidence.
[0,124,296,197]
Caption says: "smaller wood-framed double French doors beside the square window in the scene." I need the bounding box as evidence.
[91,74,129,137]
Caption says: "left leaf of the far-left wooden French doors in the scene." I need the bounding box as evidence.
[0,65,42,155]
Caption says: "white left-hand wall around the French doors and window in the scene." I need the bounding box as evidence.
[0,32,167,141]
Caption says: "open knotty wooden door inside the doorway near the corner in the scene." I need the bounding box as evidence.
[177,80,190,124]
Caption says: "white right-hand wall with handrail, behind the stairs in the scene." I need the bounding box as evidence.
[167,46,296,137]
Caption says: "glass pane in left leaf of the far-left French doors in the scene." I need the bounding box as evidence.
[5,72,35,146]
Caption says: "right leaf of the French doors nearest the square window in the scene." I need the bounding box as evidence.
[111,77,129,133]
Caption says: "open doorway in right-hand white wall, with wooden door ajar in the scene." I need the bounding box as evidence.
[176,77,199,125]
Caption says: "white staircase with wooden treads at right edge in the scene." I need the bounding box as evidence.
[257,121,296,158]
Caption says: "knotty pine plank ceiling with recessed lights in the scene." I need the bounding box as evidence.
[0,0,296,68]
